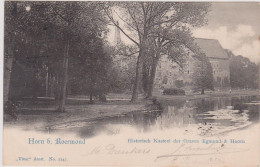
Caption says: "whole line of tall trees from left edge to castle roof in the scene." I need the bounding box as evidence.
[5,1,213,111]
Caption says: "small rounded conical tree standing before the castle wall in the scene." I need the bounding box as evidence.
[192,55,214,94]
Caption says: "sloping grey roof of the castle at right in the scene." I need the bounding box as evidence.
[195,38,228,59]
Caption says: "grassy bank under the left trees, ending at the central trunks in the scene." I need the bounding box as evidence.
[5,100,153,130]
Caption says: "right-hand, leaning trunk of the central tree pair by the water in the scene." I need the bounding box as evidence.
[145,54,160,99]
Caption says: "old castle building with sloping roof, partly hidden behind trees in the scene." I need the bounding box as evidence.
[155,38,230,89]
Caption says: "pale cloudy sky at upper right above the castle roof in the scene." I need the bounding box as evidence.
[193,2,260,63]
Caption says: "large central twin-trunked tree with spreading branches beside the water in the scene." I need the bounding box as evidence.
[104,2,209,101]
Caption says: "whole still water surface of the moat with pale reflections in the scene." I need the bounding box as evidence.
[54,96,260,137]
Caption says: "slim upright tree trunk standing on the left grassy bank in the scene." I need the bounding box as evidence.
[58,40,69,112]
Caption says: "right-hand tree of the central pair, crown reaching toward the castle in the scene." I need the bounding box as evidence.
[141,3,210,98]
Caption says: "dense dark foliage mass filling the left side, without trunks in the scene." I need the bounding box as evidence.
[5,1,111,102]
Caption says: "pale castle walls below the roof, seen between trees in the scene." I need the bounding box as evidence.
[154,56,230,90]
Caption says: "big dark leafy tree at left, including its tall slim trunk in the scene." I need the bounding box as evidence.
[5,2,107,111]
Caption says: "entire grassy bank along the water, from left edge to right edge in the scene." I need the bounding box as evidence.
[5,90,259,129]
